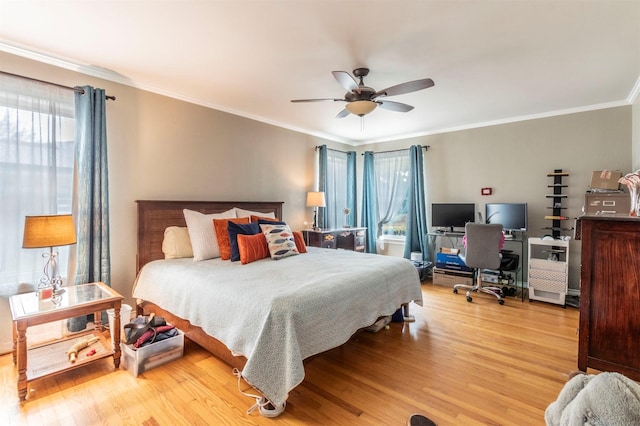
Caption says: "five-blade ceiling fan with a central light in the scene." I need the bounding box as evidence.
[291,68,435,118]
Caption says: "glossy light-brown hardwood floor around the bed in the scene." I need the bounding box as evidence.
[0,283,578,426]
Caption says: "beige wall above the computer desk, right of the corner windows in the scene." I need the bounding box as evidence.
[359,106,632,290]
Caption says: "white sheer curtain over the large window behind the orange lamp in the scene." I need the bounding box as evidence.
[0,74,75,353]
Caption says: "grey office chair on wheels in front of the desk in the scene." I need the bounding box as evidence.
[453,223,504,305]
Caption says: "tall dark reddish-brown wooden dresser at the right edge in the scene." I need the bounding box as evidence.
[577,215,640,381]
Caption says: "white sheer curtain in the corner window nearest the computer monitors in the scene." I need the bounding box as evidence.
[373,150,410,236]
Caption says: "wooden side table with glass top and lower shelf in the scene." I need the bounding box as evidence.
[9,283,123,401]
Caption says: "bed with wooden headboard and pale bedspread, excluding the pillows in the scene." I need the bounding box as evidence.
[133,201,422,407]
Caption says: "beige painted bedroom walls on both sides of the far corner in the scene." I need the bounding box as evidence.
[0,52,640,302]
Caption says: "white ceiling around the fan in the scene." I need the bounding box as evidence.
[0,0,640,145]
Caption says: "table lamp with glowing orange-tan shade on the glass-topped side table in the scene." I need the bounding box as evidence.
[22,214,76,294]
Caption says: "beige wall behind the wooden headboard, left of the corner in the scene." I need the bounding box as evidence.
[0,52,347,312]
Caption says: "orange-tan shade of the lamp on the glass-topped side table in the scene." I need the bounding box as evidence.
[22,214,76,248]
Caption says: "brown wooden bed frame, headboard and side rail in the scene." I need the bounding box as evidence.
[136,200,283,369]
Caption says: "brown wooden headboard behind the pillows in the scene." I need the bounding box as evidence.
[136,200,283,274]
